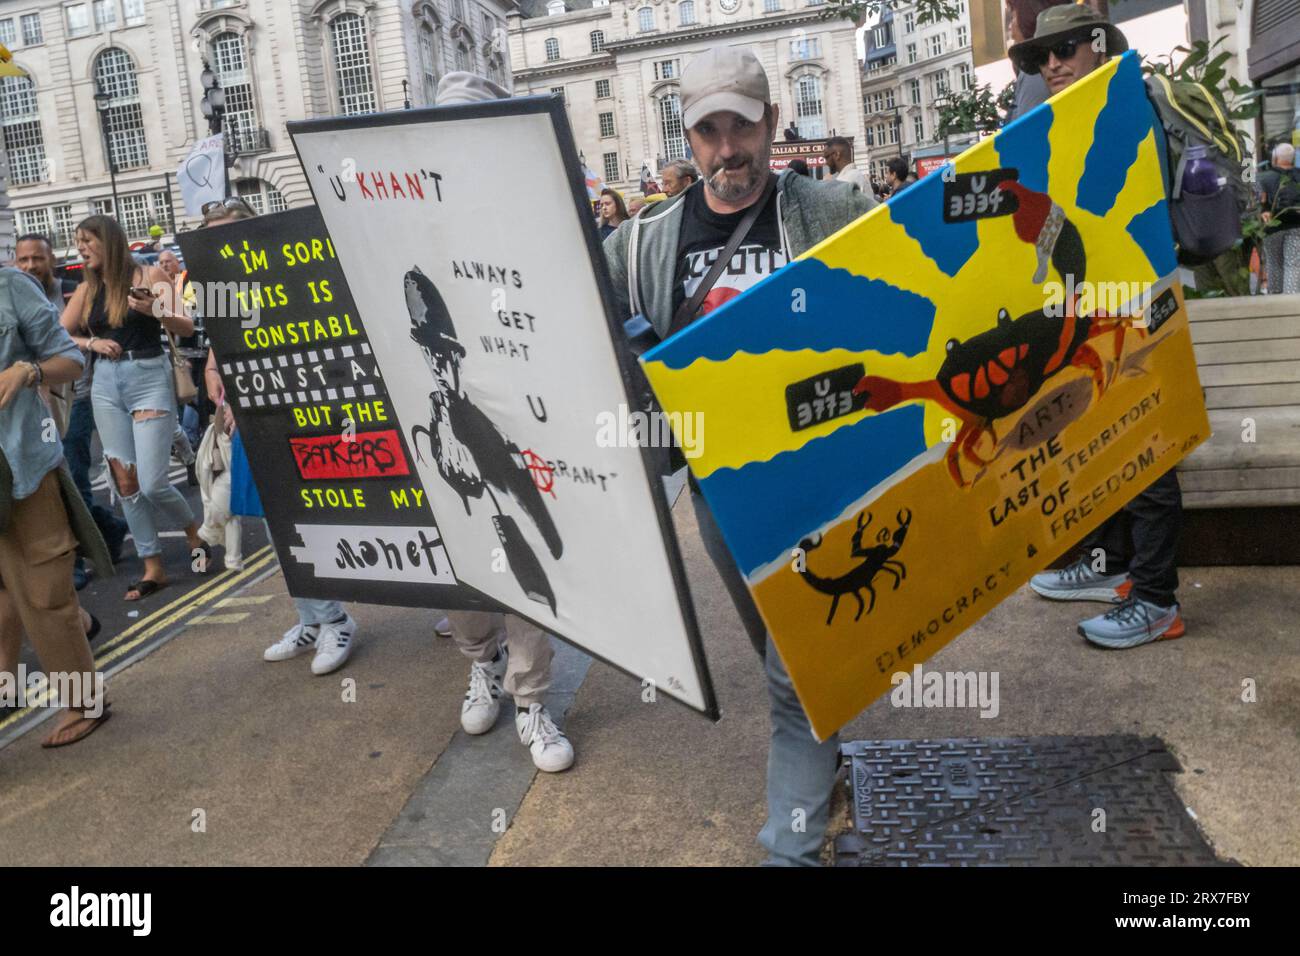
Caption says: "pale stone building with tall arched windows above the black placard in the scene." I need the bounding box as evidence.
[0,0,514,252]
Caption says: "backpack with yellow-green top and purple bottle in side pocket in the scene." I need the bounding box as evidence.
[1147,73,1251,265]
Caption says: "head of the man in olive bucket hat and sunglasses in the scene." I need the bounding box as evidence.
[1006,4,1128,96]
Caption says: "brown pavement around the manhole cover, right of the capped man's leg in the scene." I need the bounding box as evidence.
[841,567,1300,866]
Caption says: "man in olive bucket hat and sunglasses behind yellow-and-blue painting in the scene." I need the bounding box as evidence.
[1008,5,1187,649]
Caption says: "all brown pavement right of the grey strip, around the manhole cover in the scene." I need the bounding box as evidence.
[490,486,1300,866]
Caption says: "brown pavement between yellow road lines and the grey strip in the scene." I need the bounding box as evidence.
[0,574,467,866]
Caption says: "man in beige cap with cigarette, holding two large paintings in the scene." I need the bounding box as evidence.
[605,47,876,866]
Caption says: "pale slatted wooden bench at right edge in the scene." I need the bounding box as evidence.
[1178,295,1300,509]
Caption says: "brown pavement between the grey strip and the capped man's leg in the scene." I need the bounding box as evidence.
[491,496,767,866]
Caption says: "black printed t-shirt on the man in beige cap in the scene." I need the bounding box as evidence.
[672,182,787,325]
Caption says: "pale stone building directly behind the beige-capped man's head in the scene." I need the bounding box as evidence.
[507,0,870,190]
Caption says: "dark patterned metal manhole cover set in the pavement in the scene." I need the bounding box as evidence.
[835,735,1223,866]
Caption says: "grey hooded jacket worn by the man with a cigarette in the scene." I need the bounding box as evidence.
[605,170,879,338]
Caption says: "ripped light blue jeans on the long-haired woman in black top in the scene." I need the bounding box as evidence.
[91,354,194,558]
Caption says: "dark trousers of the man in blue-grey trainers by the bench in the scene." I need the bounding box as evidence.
[1083,468,1183,607]
